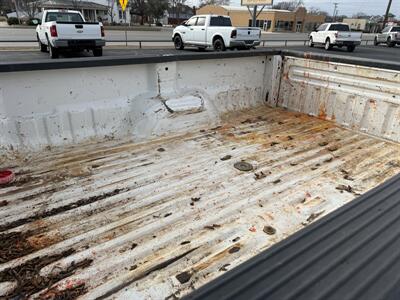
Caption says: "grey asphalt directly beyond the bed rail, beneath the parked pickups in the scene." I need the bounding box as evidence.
[0,45,400,63]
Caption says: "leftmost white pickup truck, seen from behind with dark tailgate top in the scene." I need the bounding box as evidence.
[36,10,105,58]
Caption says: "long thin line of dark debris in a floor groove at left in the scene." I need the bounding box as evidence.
[0,189,127,231]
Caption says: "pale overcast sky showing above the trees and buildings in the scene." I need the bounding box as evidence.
[187,0,400,17]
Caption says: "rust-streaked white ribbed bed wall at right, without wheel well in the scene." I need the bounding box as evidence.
[270,57,400,142]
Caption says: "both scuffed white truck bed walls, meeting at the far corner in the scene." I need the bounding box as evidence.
[0,55,400,151]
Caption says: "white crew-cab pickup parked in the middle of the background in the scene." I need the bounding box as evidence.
[172,15,261,51]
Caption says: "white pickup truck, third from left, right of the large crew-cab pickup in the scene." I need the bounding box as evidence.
[309,23,362,52]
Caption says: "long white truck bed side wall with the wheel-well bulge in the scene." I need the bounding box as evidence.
[0,56,281,150]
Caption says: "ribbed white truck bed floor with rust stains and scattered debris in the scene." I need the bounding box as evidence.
[0,107,400,299]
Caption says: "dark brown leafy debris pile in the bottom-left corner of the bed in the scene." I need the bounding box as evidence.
[0,248,92,299]
